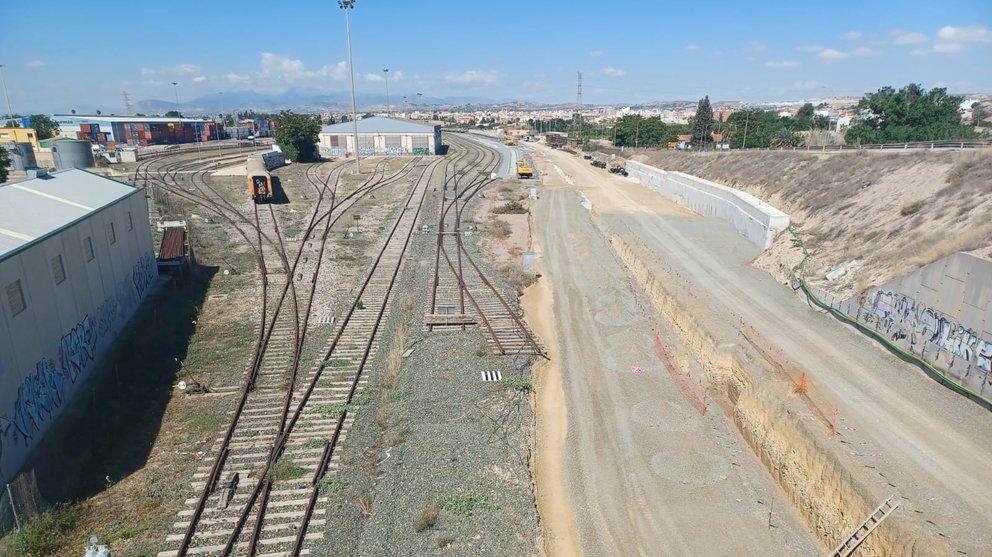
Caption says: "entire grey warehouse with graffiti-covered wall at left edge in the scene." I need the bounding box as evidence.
[0,169,157,486]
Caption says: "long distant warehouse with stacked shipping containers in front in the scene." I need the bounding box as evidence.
[52,114,217,149]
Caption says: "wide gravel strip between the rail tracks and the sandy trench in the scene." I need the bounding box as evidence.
[528,147,817,555]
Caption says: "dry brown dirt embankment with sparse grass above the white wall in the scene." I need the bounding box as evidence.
[634,149,992,297]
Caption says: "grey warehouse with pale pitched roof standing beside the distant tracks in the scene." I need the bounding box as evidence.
[320,116,441,157]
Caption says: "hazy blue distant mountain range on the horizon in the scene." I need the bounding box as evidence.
[131,89,513,116]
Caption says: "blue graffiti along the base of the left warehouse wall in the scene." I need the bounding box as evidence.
[0,255,157,472]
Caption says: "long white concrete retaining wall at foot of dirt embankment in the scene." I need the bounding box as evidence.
[627,161,789,249]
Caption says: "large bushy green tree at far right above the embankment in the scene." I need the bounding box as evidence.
[845,83,976,143]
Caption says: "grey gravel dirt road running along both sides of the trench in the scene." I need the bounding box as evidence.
[533,146,992,555]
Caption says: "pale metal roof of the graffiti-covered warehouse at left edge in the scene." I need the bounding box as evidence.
[0,168,140,260]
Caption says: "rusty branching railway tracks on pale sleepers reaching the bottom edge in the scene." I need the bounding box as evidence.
[143,150,442,556]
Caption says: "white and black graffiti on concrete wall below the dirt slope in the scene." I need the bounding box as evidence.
[860,290,992,371]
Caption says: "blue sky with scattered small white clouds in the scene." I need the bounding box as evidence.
[0,0,992,113]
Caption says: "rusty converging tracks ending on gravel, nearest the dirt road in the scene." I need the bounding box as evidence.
[424,135,546,356]
